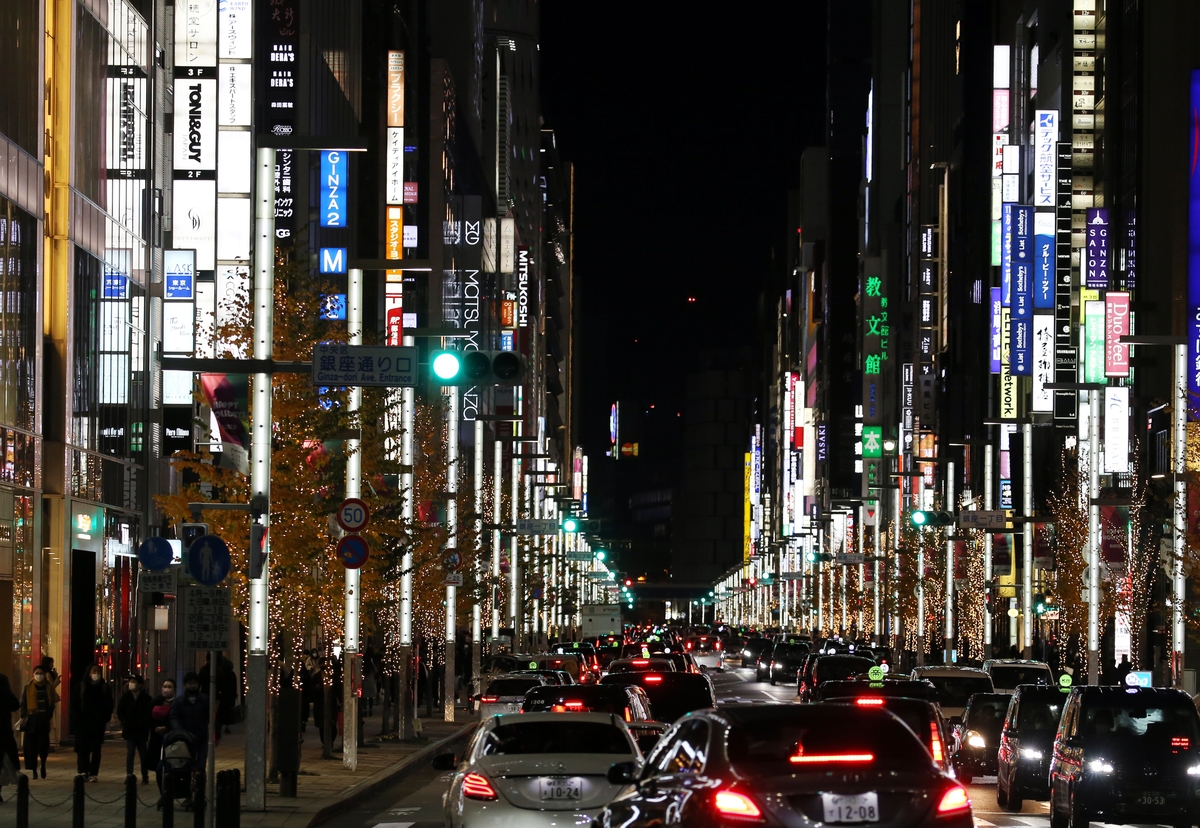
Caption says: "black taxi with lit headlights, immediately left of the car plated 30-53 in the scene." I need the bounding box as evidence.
[996,684,1070,811]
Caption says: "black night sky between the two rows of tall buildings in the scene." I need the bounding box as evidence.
[541,0,824,454]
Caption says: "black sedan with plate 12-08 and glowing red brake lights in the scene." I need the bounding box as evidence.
[598,704,973,828]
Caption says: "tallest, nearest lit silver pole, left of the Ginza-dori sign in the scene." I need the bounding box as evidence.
[247,148,275,811]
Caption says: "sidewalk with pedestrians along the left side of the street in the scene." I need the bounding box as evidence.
[0,707,478,828]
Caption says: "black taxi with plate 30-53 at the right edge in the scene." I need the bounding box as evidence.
[1050,686,1200,828]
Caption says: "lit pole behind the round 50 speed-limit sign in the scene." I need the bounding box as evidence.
[342,268,362,770]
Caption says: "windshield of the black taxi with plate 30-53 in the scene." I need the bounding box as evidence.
[1079,695,1200,750]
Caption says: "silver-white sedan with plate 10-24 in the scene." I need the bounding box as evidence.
[433,713,642,828]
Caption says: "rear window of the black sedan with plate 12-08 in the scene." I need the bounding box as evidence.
[728,704,931,775]
